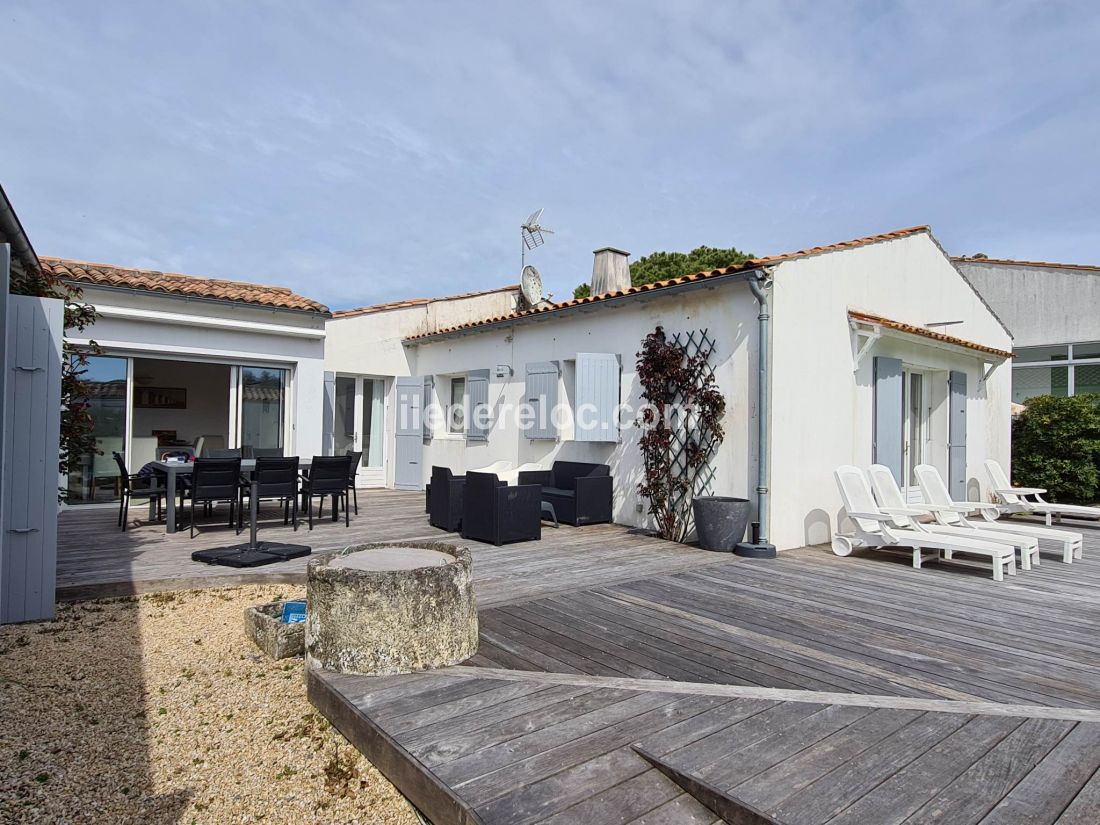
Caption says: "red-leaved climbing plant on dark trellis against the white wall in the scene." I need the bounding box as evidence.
[636,327,726,542]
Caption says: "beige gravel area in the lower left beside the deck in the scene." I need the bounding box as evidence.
[0,585,418,825]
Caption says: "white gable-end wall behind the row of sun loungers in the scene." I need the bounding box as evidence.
[770,234,1012,549]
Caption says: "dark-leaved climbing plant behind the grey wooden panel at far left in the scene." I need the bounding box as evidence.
[11,268,99,497]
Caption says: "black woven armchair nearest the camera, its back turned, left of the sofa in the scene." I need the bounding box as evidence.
[459,473,542,546]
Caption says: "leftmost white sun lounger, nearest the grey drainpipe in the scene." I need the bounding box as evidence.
[833,464,1016,582]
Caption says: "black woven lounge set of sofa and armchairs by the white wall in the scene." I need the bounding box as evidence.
[425,461,614,546]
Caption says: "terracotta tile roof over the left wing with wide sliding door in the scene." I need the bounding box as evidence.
[40,255,329,315]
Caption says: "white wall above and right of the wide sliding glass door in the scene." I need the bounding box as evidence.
[68,285,325,455]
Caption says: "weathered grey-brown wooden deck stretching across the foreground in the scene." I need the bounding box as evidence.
[62,492,1100,825]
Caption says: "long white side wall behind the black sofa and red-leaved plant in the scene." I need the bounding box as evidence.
[410,282,757,526]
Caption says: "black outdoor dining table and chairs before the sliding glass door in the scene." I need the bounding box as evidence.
[107,448,362,537]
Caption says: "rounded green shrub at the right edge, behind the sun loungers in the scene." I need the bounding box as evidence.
[1012,395,1100,504]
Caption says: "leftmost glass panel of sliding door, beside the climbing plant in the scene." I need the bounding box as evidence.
[67,355,129,504]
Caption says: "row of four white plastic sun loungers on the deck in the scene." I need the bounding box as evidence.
[833,460,1100,582]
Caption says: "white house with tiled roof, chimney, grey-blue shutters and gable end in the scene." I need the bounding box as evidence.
[326,227,1011,549]
